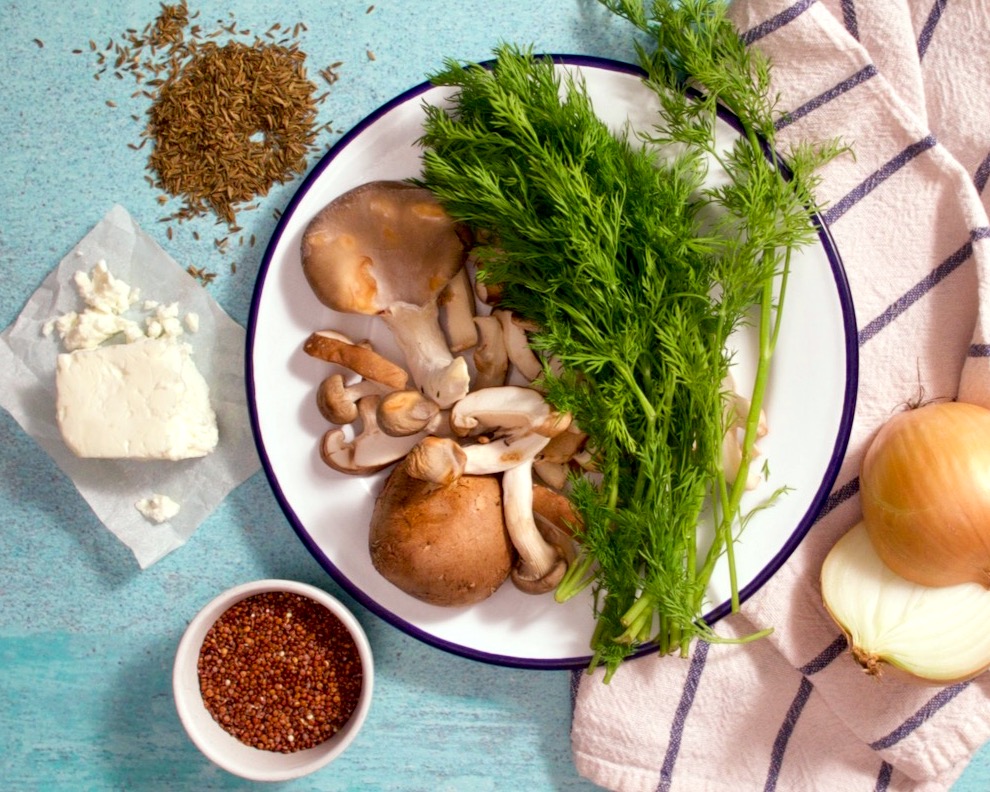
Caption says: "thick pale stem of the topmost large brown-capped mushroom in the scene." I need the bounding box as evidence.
[381,302,471,409]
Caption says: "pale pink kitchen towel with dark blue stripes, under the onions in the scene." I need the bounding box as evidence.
[572,0,990,792]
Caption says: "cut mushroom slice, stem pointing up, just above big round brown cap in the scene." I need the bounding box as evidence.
[320,396,436,475]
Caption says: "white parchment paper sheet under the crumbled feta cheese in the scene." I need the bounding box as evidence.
[0,205,260,568]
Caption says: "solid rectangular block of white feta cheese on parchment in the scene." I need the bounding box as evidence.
[55,338,218,460]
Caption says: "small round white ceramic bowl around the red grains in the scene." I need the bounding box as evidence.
[172,580,374,781]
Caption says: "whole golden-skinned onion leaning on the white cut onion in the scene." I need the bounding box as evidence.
[860,402,990,588]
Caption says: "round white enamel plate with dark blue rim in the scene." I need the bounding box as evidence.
[247,57,857,668]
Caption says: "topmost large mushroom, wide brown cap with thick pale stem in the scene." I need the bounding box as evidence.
[301,181,470,407]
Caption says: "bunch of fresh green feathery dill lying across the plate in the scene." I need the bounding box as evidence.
[420,0,838,680]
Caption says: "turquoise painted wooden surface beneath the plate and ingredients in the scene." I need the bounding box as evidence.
[0,0,990,792]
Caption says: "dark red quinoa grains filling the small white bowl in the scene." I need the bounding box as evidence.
[198,592,363,753]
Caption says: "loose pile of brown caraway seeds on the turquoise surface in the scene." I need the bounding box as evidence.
[77,0,341,232]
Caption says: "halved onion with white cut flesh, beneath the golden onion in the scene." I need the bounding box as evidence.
[821,523,990,684]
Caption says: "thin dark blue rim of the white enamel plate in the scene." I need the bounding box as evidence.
[245,54,859,670]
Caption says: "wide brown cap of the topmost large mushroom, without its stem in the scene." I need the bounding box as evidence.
[302,181,467,314]
